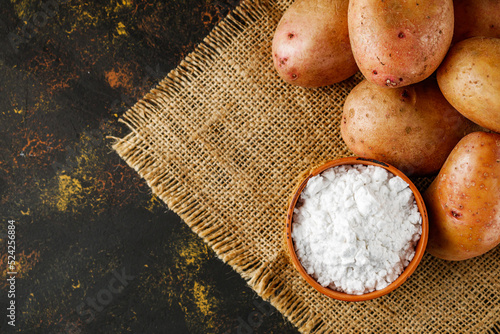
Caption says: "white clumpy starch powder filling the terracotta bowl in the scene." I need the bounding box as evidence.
[292,164,422,295]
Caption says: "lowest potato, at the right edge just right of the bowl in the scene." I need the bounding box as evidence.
[423,132,500,261]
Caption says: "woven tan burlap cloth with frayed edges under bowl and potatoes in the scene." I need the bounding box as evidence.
[113,0,500,333]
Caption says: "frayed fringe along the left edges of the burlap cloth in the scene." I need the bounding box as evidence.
[111,1,329,333]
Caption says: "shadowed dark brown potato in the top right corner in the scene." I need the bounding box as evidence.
[451,0,500,44]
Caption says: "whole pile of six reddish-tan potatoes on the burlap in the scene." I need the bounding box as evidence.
[272,0,500,260]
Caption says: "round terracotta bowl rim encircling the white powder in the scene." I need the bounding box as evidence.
[285,157,429,301]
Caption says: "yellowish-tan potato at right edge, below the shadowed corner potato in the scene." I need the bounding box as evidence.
[437,37,500,132]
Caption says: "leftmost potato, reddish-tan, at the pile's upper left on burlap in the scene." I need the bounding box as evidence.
[272,0,358,87]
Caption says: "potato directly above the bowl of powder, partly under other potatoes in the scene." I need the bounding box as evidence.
[341,77,476,175]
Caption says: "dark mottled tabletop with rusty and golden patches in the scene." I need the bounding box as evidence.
[0,0,296,333]
